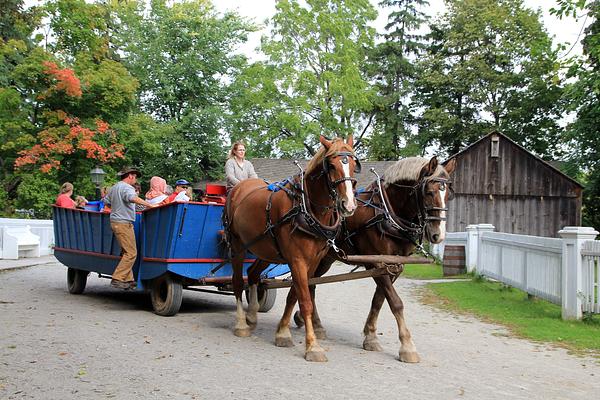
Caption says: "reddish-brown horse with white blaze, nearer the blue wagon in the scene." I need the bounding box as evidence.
[223,136,360,361]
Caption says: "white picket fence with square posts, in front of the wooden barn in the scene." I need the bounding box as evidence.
[433,224,600,319]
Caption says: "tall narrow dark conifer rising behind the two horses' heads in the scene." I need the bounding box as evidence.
[369,0,429,160]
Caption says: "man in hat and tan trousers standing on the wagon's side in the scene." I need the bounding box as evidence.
[104,167,155,290]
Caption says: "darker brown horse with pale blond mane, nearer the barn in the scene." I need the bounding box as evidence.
[288,157,456,362]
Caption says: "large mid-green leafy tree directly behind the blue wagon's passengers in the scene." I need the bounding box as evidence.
[116,0,254,179]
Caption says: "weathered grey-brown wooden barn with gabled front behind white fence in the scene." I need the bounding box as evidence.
[446,132,583,237]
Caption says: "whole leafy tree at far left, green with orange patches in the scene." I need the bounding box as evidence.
[0,0,138,215]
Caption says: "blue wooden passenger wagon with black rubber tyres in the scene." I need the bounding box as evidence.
[53,202,289,316]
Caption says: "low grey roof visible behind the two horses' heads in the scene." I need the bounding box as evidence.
[250,158,395,188]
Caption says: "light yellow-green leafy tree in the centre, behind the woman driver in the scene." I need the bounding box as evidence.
[232,0,377,156]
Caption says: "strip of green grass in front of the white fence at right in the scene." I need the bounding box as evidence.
[424,279,600,357]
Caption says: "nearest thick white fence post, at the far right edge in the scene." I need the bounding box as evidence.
[558,226,598,319]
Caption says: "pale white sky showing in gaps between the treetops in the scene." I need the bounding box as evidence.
[213,0,587,60]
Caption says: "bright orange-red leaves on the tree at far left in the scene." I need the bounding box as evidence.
[15,61,124,173]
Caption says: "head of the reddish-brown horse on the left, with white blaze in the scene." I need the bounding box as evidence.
[307,135,360,217]
